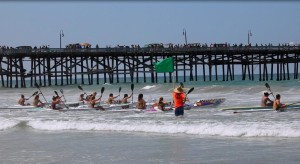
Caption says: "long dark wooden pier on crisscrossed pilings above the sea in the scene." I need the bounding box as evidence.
[0,46,300,88]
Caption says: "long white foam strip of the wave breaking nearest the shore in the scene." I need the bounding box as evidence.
[28,120,300,137]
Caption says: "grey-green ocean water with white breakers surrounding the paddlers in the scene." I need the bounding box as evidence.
[0,77,300,164]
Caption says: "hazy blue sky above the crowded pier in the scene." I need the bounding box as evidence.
[0,1,300,48]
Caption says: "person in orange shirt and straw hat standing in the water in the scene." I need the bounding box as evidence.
[172,86,186,117]
